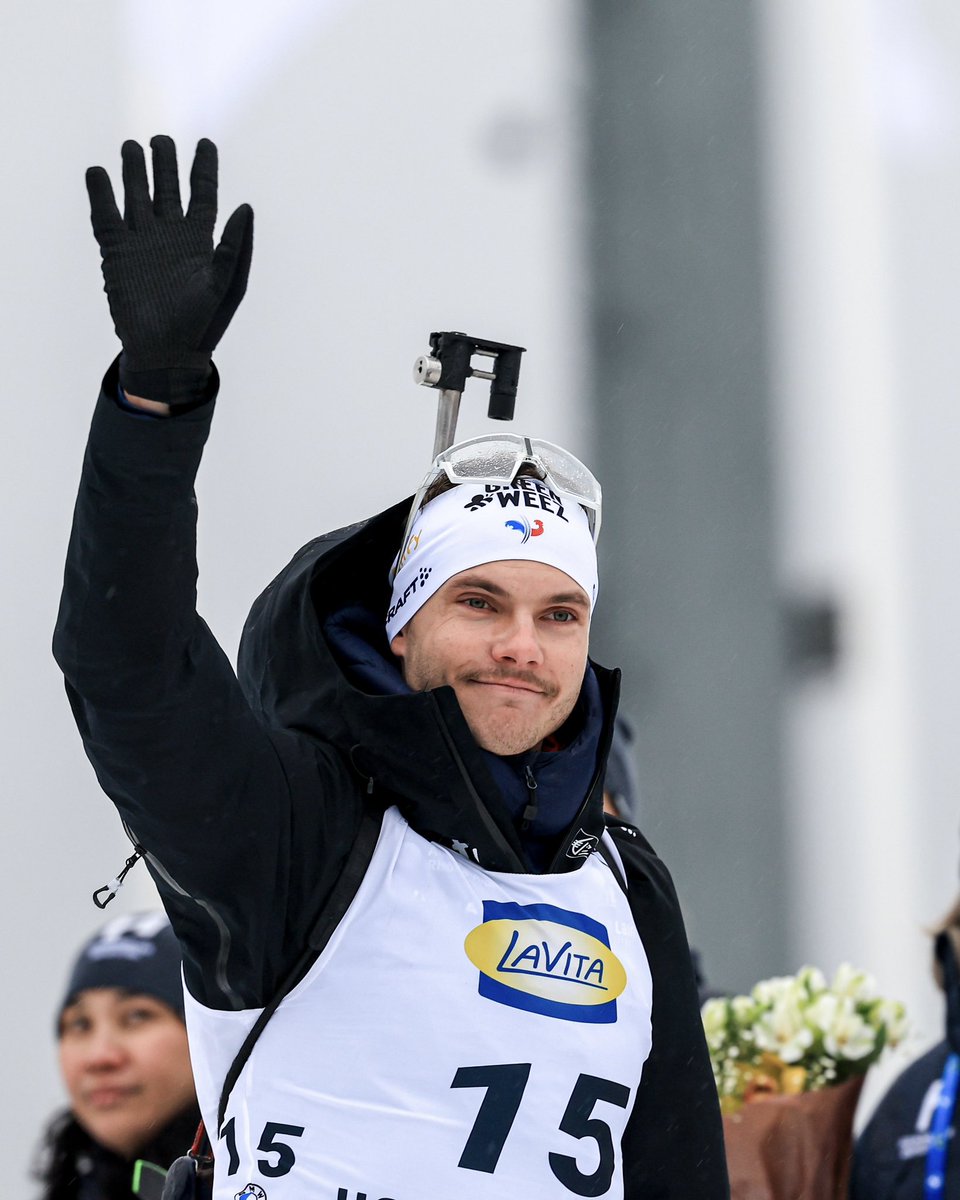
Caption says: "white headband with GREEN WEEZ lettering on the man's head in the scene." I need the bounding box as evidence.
[386,475,598,641]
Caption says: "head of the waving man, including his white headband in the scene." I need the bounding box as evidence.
[386,470,600,755]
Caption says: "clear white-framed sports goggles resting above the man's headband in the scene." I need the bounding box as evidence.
[391,433,602,578]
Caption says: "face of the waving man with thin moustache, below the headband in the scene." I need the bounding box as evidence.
[390,559,590,755]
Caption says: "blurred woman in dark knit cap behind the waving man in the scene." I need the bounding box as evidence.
[35,913,200,1200]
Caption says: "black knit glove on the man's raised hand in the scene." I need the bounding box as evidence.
[86,137,253,407]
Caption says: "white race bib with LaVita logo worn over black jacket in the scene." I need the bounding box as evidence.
[186,809,652,1200]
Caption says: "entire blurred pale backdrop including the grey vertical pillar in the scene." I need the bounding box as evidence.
[0,0,960,1180]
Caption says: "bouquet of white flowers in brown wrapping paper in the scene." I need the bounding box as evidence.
[703,964,906,1200]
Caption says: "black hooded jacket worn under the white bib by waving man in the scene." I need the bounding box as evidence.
[54,368,727,1200]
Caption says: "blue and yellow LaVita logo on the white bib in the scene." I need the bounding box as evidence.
[463,900,626,1025]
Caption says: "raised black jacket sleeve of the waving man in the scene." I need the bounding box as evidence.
[54,364,359,1008]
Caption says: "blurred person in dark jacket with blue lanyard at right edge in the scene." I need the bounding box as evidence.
[850,896,960,1200]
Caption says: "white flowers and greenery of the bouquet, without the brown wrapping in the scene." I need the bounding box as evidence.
[702,962,906,1112]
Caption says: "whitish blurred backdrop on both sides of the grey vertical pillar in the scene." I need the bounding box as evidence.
[0,0,960,1180]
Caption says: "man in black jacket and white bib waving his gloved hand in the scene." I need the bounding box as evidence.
[55,138,727,1200]
